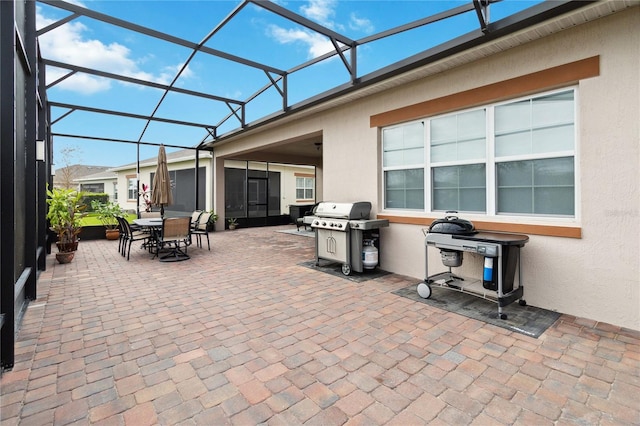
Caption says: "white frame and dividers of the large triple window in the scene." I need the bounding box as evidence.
[380,86,581,224]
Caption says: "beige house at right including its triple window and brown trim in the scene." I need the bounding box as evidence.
[212,2,640,330]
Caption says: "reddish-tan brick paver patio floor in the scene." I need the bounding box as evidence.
[0,227,640,426]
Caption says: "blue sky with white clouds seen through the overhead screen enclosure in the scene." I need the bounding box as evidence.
[36,0,540,168]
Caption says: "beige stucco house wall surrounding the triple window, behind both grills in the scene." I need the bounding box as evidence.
[216,7,640,330]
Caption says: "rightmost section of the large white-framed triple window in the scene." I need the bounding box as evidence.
[495,90,575,216]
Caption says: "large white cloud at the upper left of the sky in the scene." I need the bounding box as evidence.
[36,6,186,94]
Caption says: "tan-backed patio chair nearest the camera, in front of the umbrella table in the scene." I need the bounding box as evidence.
[154,216,191,262]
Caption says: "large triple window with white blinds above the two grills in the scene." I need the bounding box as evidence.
[382,89,576,217]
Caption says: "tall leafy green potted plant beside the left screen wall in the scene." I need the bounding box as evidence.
[47,188,87,263]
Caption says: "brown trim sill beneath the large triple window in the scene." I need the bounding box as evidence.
[377,214,582,238]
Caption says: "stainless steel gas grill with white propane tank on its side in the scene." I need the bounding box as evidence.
[311,201,389,275]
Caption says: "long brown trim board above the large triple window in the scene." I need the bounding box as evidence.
[369,56,600,127]
